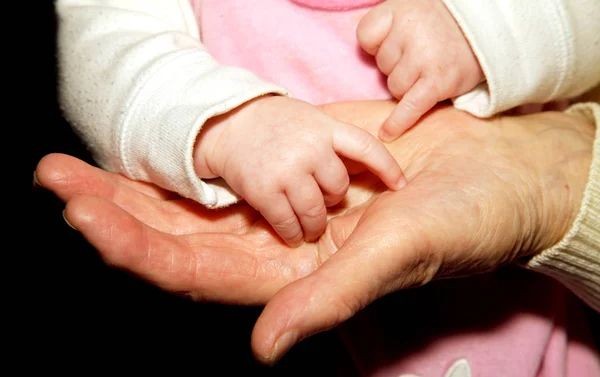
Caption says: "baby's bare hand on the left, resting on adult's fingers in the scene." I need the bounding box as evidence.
[194,96,406,246]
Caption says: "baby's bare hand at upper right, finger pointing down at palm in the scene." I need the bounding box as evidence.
[357,0,484,141]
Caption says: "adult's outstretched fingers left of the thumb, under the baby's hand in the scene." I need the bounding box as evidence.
[35,154,340,305]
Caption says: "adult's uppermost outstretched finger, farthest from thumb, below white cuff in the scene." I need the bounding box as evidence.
[35,154,255,234]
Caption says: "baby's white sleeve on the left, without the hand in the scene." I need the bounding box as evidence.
[56,0,286,207]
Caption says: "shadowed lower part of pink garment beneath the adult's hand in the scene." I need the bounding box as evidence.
[341,268,600,377]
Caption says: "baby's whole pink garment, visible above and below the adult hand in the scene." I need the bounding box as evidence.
[191,0,600,377]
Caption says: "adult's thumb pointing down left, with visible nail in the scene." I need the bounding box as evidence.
[252,192,426,364]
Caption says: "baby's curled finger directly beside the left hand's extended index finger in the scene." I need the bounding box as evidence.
[313,155,350,207]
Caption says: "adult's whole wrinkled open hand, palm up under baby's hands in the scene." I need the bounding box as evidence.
[36,102,595,363]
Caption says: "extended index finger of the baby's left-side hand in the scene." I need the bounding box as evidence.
[333,122,406,190]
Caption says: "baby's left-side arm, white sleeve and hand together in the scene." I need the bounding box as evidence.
[57,0,402,244]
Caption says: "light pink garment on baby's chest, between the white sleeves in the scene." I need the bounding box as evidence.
[195,0,391,104]
